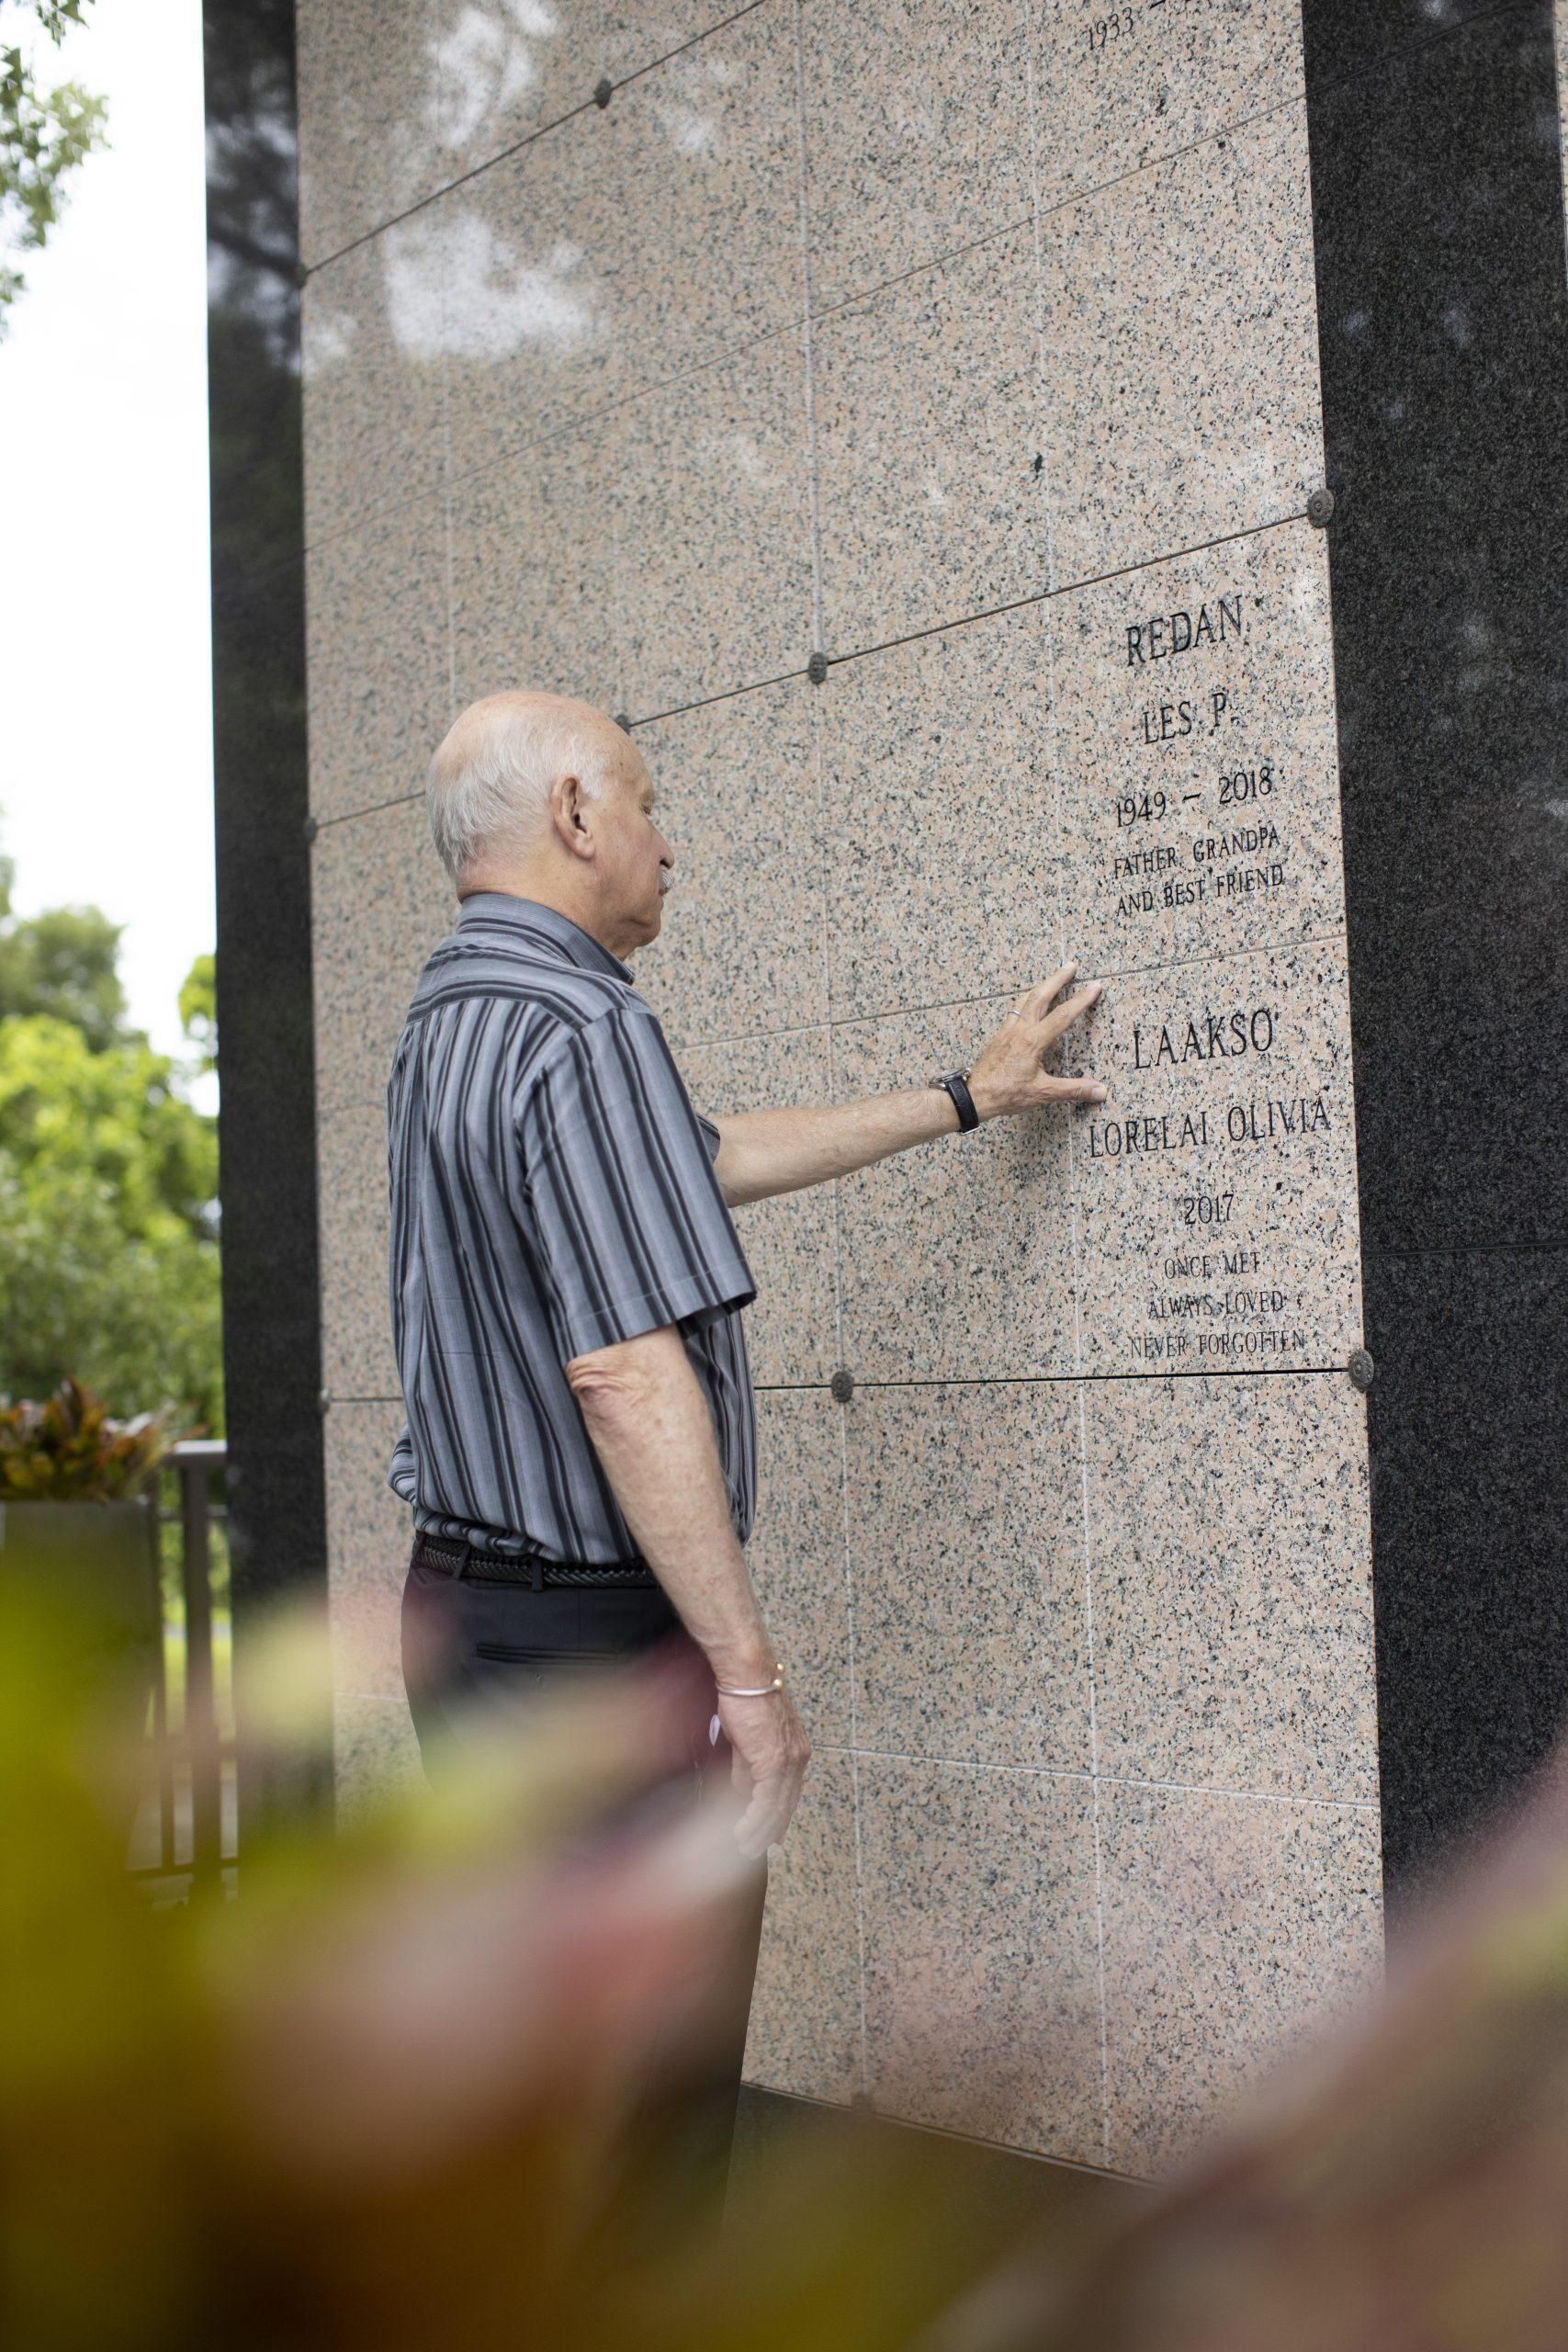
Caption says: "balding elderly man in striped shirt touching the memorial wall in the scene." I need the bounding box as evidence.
[388,694,1105,2154]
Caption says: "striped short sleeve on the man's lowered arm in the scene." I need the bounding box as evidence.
[517,1004,757,1364]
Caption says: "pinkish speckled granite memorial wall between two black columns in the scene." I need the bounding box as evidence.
[299,0,1382,2171]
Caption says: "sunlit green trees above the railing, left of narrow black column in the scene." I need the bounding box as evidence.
[0,868,221,1430]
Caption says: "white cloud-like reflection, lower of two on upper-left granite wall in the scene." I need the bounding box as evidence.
[383,211,602,360]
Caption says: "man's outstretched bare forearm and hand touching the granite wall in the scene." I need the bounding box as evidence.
[715,965,1105,1206]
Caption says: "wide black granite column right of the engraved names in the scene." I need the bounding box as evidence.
[1303,0,1568,1891]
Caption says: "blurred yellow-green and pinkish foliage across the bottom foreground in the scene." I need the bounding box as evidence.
[0,1561,1568,2352]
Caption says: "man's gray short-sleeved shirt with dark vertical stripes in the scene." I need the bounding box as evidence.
[388,891,757,1562]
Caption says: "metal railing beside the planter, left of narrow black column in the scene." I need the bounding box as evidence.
[130,1440,237,1894]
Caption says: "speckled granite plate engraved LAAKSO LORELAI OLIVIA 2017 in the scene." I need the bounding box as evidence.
[1072,941,1361,1374]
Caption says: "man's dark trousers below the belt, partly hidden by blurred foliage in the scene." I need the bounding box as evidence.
[402,1562,766,2218]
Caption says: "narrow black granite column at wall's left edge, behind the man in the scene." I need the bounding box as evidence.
[205,0,327,1796]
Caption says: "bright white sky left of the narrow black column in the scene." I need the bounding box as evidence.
[0,0,214,1051]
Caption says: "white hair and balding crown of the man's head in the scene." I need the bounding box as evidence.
[425,694,616,889]
